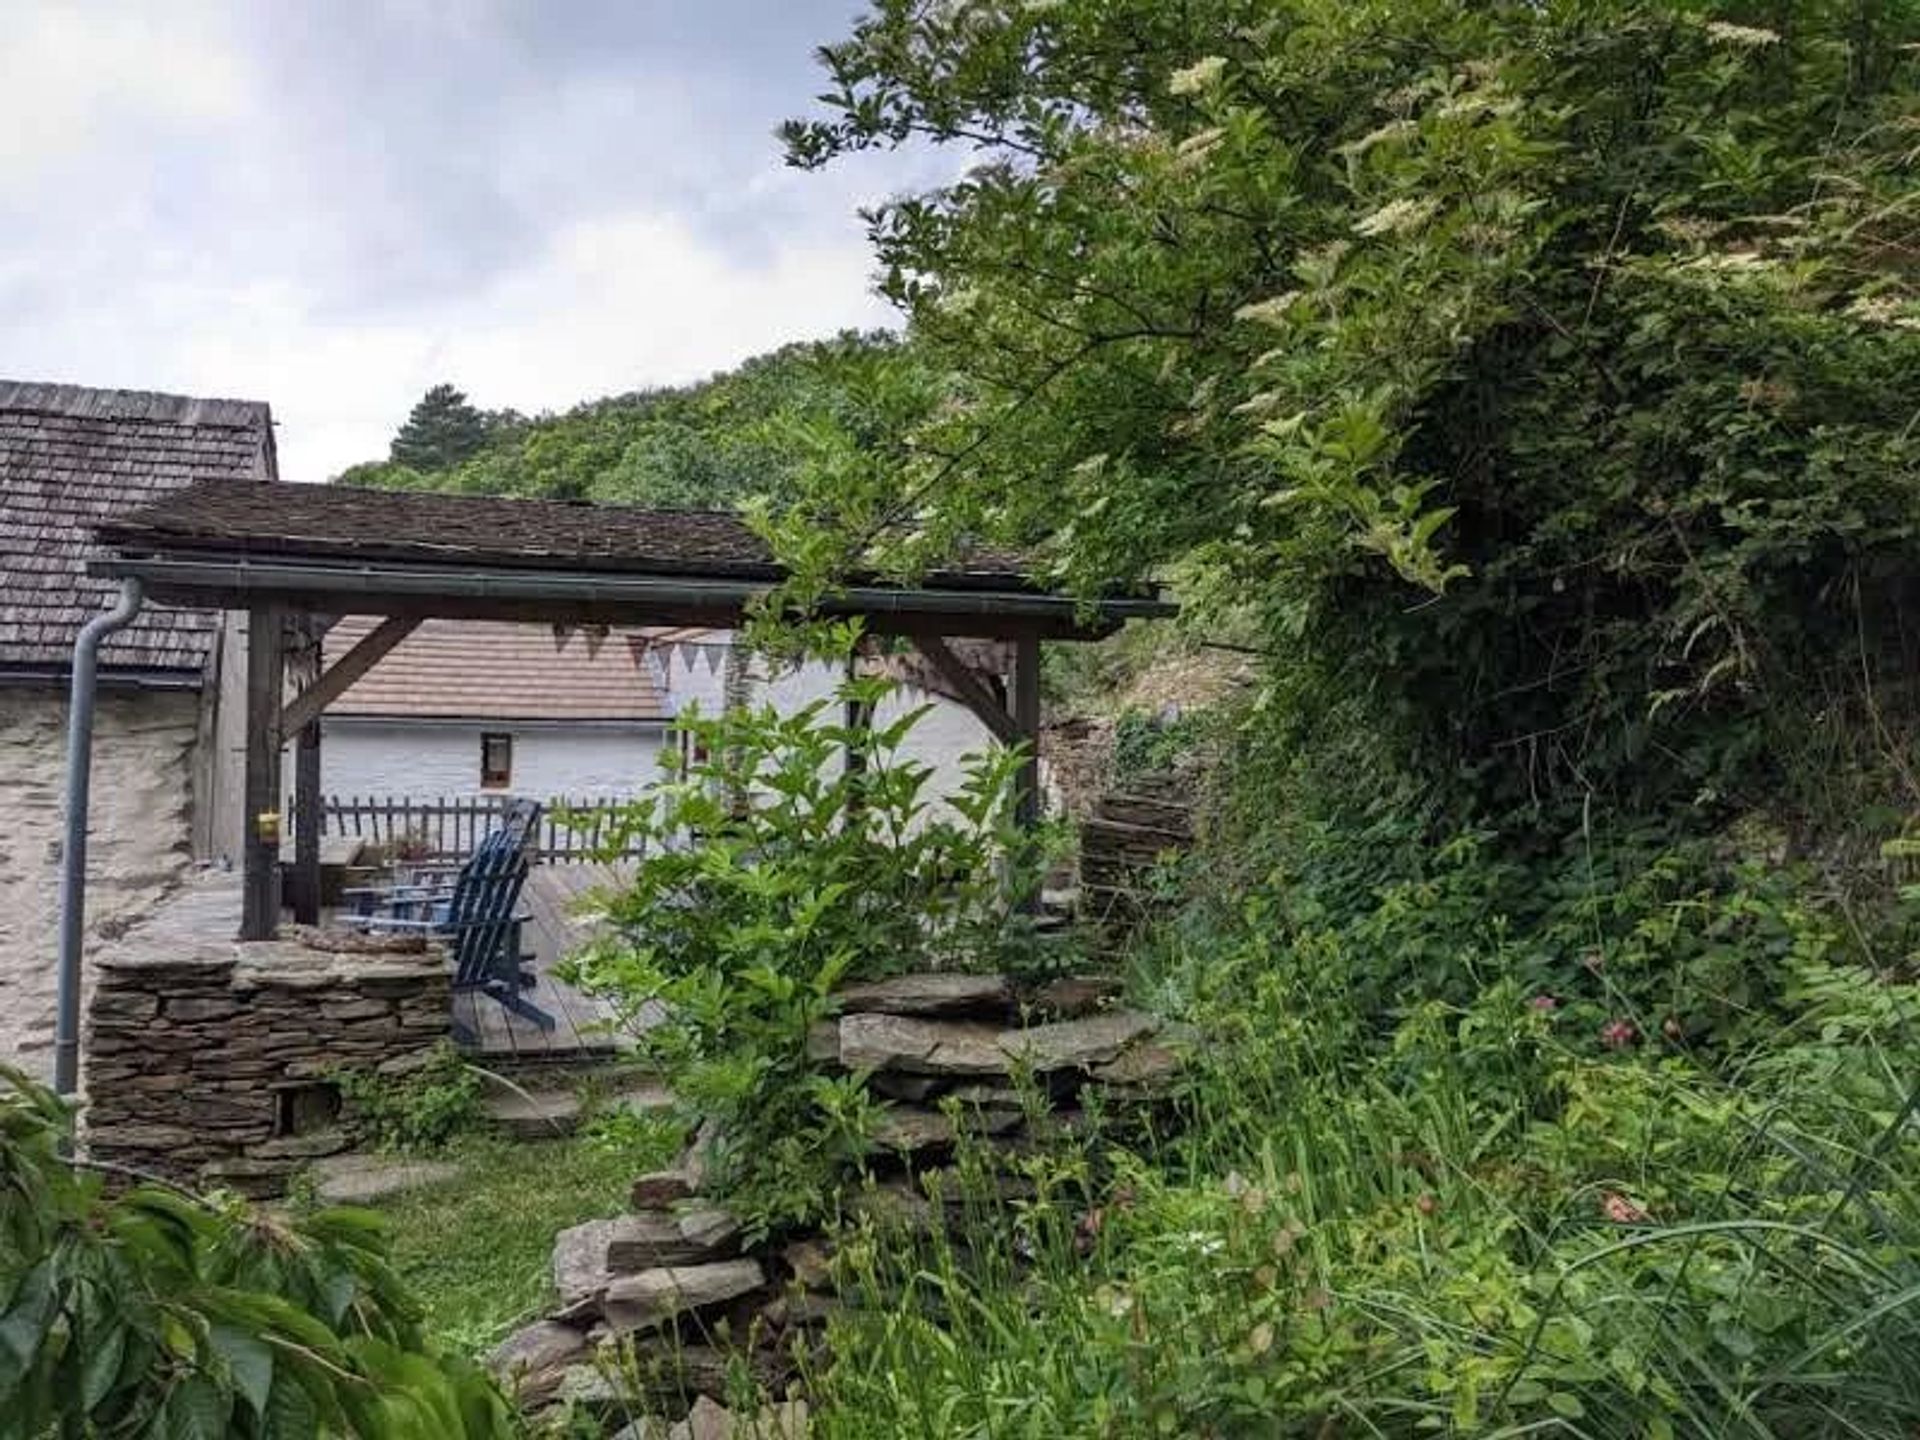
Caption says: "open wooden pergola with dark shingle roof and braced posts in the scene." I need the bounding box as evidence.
[90,484,1175,941]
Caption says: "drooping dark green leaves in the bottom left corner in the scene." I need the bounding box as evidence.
[0,1069,513,1440]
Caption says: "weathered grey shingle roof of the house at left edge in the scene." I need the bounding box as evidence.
[0,380,276,674]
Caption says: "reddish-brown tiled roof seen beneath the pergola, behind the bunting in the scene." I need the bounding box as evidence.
[324,616,670,722]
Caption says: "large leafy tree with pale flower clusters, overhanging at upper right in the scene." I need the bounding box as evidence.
[783,0,1920,833]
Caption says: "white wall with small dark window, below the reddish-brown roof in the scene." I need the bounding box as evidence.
[314,716,664,801]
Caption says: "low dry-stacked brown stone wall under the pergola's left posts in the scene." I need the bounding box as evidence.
[84,931,451,1196]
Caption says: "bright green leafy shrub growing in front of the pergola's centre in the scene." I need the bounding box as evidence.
[574,632,1050,1231]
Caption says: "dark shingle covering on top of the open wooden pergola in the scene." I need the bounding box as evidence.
[98,486,1029,589]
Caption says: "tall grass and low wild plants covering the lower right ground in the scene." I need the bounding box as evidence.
[794,898,1920,1438]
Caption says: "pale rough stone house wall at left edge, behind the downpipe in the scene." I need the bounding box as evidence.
[0,687,200,1079]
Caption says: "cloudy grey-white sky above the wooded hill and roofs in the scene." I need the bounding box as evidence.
[0,0,929,480]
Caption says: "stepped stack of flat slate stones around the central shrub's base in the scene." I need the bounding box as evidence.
[493,973,1181,1440]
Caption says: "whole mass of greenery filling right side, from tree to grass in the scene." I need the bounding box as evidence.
[741,0,1920,1436]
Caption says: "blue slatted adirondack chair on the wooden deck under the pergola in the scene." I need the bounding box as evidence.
[351,801,555,1044]
